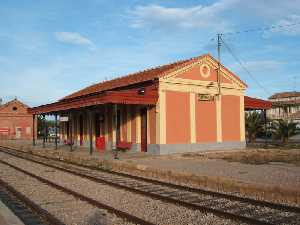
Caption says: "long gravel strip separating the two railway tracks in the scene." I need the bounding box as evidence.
[0,151,246,225]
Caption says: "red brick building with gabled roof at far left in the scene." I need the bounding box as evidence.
[0,99,33,140]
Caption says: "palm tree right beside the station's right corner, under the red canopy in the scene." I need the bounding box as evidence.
[245,111,263,143]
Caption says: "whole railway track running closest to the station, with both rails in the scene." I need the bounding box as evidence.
[0,148,300,224]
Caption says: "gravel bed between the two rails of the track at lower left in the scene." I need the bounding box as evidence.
[0,163,135,225]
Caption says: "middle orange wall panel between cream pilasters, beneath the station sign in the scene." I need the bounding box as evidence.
[195,97,217,143]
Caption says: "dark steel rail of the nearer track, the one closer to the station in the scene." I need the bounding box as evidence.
[0,160,154,225]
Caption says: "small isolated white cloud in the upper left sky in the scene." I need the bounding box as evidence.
[54,32,94,46]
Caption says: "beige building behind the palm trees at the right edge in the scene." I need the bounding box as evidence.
[267,91,300,122]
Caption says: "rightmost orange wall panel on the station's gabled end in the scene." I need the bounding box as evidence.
[221,95,240,141]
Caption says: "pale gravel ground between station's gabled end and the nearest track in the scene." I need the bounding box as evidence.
[125,156,300,189]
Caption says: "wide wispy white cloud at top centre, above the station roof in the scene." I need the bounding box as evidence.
[130,0,237,31]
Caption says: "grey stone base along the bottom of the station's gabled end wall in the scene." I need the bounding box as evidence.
[148,141,246,155]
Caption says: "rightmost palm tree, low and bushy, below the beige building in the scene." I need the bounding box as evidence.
[272,120,299,144]
